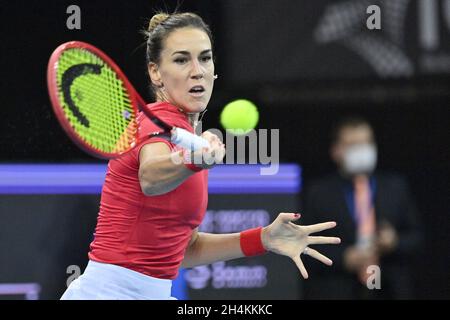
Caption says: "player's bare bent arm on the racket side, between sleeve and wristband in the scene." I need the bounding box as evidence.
[139,151,194,196]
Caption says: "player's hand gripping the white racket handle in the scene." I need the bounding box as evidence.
[192,131,225,169]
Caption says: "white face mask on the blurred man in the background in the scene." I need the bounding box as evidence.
[343,143,377,175]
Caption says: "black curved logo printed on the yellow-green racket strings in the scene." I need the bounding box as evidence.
[61,63,102,128]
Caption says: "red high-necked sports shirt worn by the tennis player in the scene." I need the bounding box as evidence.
[89,102,208,279]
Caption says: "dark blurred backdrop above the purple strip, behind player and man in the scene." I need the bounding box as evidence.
[0,0,450,299]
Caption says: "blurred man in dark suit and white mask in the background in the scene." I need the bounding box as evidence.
[303,117,421,299]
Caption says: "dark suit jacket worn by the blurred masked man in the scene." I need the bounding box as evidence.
[301,173,422,299]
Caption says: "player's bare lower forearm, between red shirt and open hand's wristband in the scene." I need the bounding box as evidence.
[181,232,244,268]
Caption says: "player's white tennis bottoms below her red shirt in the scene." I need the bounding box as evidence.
[61,260,175,300]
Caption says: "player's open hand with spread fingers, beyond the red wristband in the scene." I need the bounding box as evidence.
[261,213,341,279]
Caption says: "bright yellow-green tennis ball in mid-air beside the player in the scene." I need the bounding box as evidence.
[220,99,259,135]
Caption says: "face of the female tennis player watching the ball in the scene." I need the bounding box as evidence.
[150,28,214,113]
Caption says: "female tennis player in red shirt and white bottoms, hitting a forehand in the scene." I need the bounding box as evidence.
[61,13,340,300]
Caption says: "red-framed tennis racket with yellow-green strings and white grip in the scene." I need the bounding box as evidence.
[47,41,209,159]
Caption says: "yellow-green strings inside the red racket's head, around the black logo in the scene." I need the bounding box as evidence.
[57,48,137,153]
